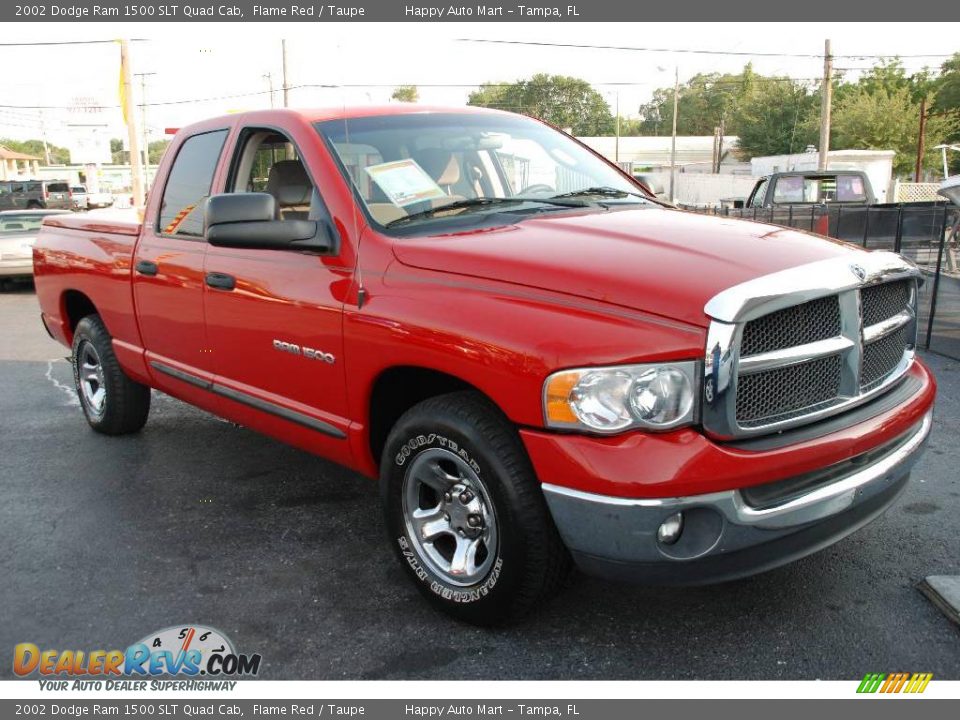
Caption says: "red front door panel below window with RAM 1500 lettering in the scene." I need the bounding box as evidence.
[205,246,352,461]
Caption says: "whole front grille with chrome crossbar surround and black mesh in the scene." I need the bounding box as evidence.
[702,252,922,440]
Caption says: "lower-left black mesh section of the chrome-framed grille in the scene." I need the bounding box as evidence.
[737,355,840,428]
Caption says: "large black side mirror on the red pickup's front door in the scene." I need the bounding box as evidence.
[203,193,336,252]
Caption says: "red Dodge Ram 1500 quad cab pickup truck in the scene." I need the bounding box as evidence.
[34,106,935,624]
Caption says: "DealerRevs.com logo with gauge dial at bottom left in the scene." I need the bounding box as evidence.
[13,625,261,690]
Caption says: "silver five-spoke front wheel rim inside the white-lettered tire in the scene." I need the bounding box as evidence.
[403,448,497,586]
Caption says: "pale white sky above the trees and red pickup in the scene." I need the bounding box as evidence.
[0,23,960,152]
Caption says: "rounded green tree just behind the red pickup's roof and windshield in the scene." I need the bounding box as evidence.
[467,73,614,136]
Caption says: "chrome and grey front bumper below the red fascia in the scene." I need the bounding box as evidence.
[543,411,933,584]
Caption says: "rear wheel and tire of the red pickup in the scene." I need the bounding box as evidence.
[73,315,150,435]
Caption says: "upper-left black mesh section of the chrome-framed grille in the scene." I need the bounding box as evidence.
[740,295,840,355]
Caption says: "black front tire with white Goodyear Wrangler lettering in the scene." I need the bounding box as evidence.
[380,392,571,626]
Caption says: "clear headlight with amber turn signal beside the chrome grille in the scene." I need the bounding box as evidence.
[543,360,698,433]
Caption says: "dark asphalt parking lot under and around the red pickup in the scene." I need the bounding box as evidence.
[0,287,960,680]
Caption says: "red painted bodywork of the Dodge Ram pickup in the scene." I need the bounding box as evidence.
[35,105,934,506]
